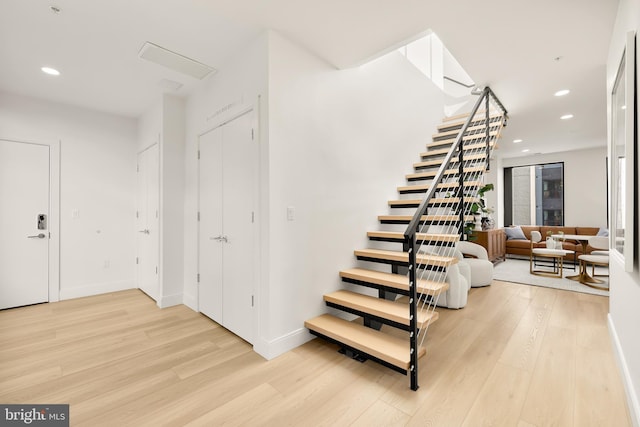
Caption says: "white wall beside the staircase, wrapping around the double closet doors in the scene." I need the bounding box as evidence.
[184,32,443,358]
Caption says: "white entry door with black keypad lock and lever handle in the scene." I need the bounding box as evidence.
[0,140,50,309]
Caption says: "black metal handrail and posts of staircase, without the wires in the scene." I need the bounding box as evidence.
[404,87,507,390]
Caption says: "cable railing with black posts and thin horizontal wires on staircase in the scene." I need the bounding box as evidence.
[404,87,507,390]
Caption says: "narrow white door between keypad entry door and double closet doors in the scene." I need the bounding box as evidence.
[136,144,160,301]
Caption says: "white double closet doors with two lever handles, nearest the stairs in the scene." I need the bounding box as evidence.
[198,113,256,342]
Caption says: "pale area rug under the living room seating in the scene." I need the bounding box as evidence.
[493,259,609,296]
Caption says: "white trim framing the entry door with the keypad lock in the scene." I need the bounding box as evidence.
[0,139,60,302]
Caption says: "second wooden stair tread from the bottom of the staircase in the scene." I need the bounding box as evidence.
[324,290,438,329]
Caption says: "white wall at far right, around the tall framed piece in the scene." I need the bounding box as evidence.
[607,0,640,427]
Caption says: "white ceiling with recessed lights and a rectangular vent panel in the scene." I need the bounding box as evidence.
[0,0,618,157]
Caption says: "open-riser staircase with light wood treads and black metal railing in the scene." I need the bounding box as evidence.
[305,88,507,390]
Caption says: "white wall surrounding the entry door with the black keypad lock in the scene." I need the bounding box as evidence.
[0,93,136,299]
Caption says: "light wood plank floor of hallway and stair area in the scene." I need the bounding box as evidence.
[0,282,631,427]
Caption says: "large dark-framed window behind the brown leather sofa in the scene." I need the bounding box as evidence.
[504,162,564,225]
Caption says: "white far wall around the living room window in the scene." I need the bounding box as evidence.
[486,146,607,227]
